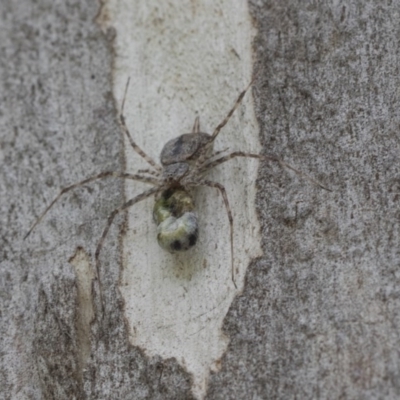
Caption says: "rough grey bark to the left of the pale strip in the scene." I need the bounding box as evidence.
[0,0,191,399]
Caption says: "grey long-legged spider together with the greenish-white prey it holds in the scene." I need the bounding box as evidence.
[24,76,329,308]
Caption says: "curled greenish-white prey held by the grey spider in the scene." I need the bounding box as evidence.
[153,187,198,253]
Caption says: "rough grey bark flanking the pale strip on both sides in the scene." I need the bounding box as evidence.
[0,0,400,399]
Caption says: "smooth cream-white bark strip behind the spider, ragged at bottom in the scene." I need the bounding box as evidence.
[99,0,261,398]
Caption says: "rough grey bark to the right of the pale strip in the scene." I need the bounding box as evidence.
[208,1,400,399]
